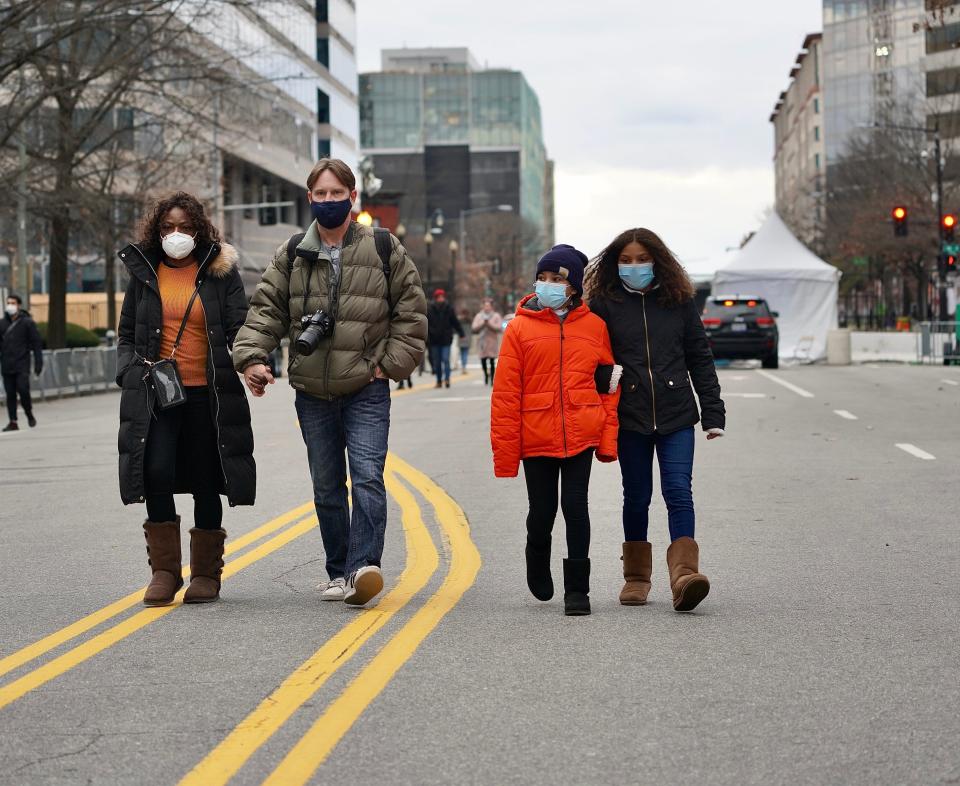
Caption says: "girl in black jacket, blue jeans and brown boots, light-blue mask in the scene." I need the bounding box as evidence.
[586,229,726,611]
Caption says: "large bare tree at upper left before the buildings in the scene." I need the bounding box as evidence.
[0,0,264,347]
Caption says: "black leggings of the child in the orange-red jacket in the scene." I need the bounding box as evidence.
[523,448,593,559]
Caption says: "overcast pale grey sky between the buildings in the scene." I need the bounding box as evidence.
[357,0,822,262]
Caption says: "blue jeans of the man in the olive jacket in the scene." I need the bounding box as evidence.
[296,379,390,579]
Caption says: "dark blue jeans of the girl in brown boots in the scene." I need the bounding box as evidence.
[617,426,695,542]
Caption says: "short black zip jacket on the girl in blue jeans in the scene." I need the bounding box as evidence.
[590,289,726,434]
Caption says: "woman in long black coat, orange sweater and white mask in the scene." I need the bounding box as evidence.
[117,192,256,606]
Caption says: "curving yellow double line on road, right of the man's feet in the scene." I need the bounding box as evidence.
[180,455,480,786]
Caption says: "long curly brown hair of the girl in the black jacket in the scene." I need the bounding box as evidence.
[584,229,696,306]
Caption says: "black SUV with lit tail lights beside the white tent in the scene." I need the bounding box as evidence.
[703,295,780,368]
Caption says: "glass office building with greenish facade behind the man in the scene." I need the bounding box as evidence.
[360,49,553,266]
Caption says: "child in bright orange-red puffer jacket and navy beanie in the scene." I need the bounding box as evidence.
[490,245,621,615]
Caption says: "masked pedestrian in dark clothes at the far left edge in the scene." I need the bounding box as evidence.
[0,295,43,431]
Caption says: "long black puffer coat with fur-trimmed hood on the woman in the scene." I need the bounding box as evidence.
[117,243,257,505]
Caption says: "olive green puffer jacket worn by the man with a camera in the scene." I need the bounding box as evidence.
[233,222,427,399]
